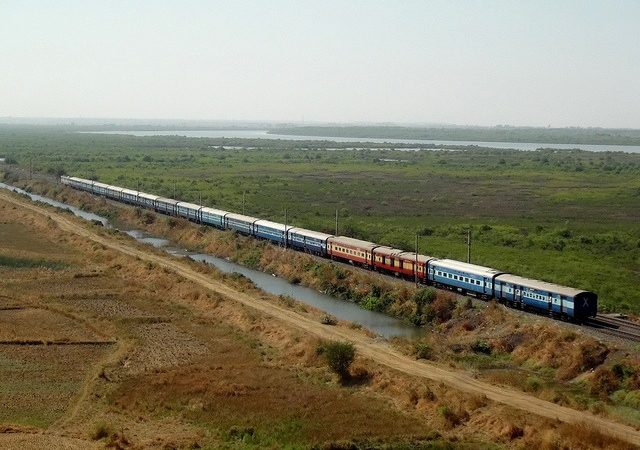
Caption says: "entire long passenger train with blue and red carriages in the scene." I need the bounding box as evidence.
[60,176,598,322]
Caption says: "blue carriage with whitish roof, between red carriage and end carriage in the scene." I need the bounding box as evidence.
[428,259,504,298]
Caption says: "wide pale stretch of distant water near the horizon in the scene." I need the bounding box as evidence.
[88,130,640,153]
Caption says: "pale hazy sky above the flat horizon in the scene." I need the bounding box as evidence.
[0,0,640,128]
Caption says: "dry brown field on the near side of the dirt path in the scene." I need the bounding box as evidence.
[0,178,640,448]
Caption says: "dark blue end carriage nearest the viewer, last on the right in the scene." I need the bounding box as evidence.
[495,274,597,320]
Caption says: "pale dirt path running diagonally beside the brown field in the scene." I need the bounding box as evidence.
[5,192,640,447]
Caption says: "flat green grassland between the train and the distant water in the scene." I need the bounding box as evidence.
[0,127,640,312]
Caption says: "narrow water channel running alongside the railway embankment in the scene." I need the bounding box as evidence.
[0,183,426,338]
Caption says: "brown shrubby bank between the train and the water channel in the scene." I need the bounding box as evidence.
[13,181,465,326]
